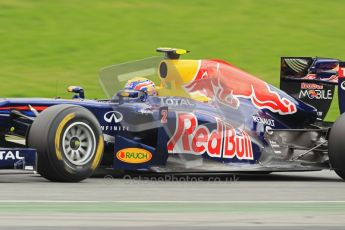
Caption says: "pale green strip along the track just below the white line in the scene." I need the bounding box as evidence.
[0,201,345,214]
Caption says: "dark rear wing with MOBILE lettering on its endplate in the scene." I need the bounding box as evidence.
[280,57,345,120]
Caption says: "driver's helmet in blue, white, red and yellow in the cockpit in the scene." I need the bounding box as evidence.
[125,77,158,96]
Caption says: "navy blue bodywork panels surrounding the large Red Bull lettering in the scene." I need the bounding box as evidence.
[0,87,316,171]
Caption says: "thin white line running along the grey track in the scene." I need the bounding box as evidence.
[0,200,345,204]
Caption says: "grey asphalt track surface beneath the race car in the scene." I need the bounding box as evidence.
[0,171,345,229]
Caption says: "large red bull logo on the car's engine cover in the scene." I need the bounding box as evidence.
[184,61,297,115]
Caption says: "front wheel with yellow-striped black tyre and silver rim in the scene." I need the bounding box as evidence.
[27,105,104,182]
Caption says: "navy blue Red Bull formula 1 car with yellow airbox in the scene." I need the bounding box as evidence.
[0,48,345,182]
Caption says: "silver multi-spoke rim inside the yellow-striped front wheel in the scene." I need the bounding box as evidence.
[62,122,96,165]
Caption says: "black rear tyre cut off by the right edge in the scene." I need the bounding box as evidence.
[328,114,345,180]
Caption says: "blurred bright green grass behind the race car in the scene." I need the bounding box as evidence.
[0,0,345,119]
